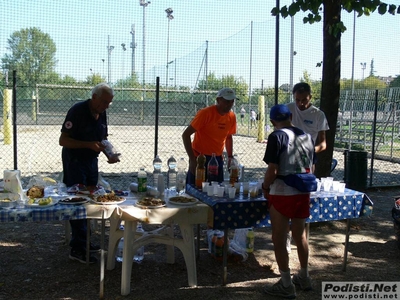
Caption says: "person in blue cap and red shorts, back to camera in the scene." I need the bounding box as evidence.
[262,104,315,299]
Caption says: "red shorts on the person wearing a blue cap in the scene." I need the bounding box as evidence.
[268,194,310,219]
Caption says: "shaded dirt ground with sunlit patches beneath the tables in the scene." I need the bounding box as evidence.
[0,188,400,300]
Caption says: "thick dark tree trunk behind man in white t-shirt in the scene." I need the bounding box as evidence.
[316,0,341,177]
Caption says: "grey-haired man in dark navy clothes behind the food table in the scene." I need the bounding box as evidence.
[59,83,119,263]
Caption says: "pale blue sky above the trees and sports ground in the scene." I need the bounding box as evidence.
[0,0,400,88]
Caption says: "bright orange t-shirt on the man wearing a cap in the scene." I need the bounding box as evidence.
[190,105,236,156]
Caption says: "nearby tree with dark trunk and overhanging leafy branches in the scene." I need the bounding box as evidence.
[271,0,400,177]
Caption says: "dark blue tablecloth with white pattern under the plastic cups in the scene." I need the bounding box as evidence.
[186,185,373,230]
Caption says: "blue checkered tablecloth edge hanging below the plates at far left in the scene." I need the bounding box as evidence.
[0,204,87,222]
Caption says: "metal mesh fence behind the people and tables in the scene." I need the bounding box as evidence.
[0,83,400,189]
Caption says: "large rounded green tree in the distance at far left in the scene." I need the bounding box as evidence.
[1,27,57,84]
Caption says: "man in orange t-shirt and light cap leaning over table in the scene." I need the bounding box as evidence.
[182,88,237,184]
